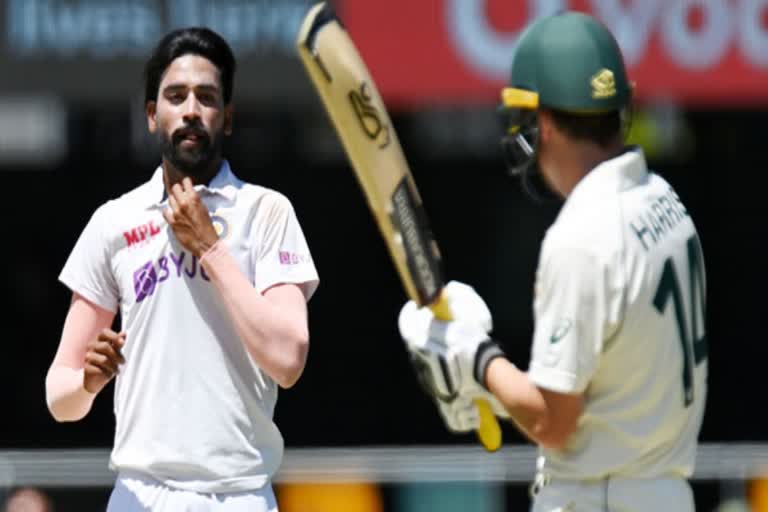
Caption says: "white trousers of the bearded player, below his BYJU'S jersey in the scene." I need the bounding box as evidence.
[107,473,277,512]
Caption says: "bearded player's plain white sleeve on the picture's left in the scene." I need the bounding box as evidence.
[59,205,119,312]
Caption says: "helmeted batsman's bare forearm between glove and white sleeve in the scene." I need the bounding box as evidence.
[485,358,573,449]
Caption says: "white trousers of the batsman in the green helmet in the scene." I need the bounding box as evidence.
[532,477,695,512]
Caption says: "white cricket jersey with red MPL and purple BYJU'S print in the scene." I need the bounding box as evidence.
[59,161,318,493]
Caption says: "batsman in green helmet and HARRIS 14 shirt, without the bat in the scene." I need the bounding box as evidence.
[399,12,707,512]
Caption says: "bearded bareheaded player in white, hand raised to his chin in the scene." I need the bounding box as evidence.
[46,28,318,512]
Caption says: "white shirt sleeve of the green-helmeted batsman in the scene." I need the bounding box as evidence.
[529,243,615,393]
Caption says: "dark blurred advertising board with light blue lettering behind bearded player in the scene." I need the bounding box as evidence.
[0,0,314,103]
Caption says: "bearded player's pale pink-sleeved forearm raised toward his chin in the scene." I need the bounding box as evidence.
[200,243,309,388]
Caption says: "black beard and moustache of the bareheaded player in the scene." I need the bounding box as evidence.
[160,125,223,178]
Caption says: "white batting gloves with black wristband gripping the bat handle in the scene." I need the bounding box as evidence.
[398,281,508,420]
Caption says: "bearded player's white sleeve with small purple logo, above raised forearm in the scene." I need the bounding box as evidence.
[254,193,319,300]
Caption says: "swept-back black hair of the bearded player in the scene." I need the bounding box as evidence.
[144,27,235,104]
